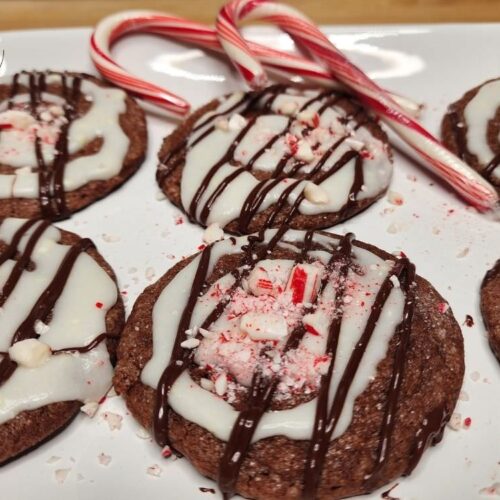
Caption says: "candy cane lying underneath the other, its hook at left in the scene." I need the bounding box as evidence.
[90,10,420,117]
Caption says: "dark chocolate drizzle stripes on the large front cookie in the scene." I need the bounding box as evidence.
[149,228,438,498]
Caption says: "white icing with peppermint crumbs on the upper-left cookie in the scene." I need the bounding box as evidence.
[0,73,130,199]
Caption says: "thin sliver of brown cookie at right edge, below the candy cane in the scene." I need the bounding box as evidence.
[481,260,500,361]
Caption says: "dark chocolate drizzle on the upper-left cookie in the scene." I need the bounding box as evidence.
[8,72,81,220]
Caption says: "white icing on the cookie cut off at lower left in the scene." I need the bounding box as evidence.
[0,219,117,424]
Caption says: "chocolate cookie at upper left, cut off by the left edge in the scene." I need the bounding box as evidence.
[0,71,147,220]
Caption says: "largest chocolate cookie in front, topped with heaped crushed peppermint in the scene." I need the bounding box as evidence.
[114,228,464,499]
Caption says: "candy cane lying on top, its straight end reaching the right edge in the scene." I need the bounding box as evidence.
[216,0,498,210]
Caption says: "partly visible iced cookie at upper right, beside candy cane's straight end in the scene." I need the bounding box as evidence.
[441,78,500,192]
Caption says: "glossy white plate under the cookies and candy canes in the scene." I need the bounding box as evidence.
[0,24,500,500]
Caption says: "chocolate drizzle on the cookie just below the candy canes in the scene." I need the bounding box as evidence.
[157,85,376,234]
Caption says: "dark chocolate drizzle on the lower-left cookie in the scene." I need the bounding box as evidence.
[0,220,98,386]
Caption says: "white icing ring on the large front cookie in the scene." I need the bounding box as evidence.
[141,230,405,441]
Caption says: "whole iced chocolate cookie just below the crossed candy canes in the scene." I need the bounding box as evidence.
[157,85,392,234]
